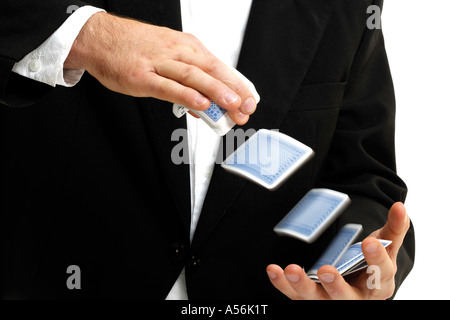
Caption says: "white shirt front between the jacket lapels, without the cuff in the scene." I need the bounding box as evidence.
[166,0,252,300]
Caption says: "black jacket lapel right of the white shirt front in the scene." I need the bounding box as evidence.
[192,0,331,250]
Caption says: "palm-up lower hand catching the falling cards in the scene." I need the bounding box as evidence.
[267,203,410,300]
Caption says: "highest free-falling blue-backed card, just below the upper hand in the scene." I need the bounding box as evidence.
[222,129,314,190]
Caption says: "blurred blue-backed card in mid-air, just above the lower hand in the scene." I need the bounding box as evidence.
[274,189,350,243]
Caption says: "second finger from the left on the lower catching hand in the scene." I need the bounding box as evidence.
[284,264,328,300]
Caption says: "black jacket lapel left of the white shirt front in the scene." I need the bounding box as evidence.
[107,0,191,238]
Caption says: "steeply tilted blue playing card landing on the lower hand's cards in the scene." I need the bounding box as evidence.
[307,224,363,279]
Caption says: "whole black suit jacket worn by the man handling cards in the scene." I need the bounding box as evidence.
[0,0,414,299]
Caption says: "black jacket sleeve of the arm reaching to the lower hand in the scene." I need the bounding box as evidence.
[318,1,415,298]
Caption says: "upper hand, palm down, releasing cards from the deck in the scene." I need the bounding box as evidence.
[64,12,256,125]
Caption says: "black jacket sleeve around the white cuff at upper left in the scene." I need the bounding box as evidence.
[0,0,86,106]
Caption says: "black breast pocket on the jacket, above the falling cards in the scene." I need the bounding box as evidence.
[289,82,347,112]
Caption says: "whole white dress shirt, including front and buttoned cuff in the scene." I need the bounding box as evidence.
[13,0,252,300]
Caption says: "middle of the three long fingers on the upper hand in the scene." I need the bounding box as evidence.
[155,60,242,110]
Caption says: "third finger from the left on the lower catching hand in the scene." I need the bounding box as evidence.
[317,266,361,300]
